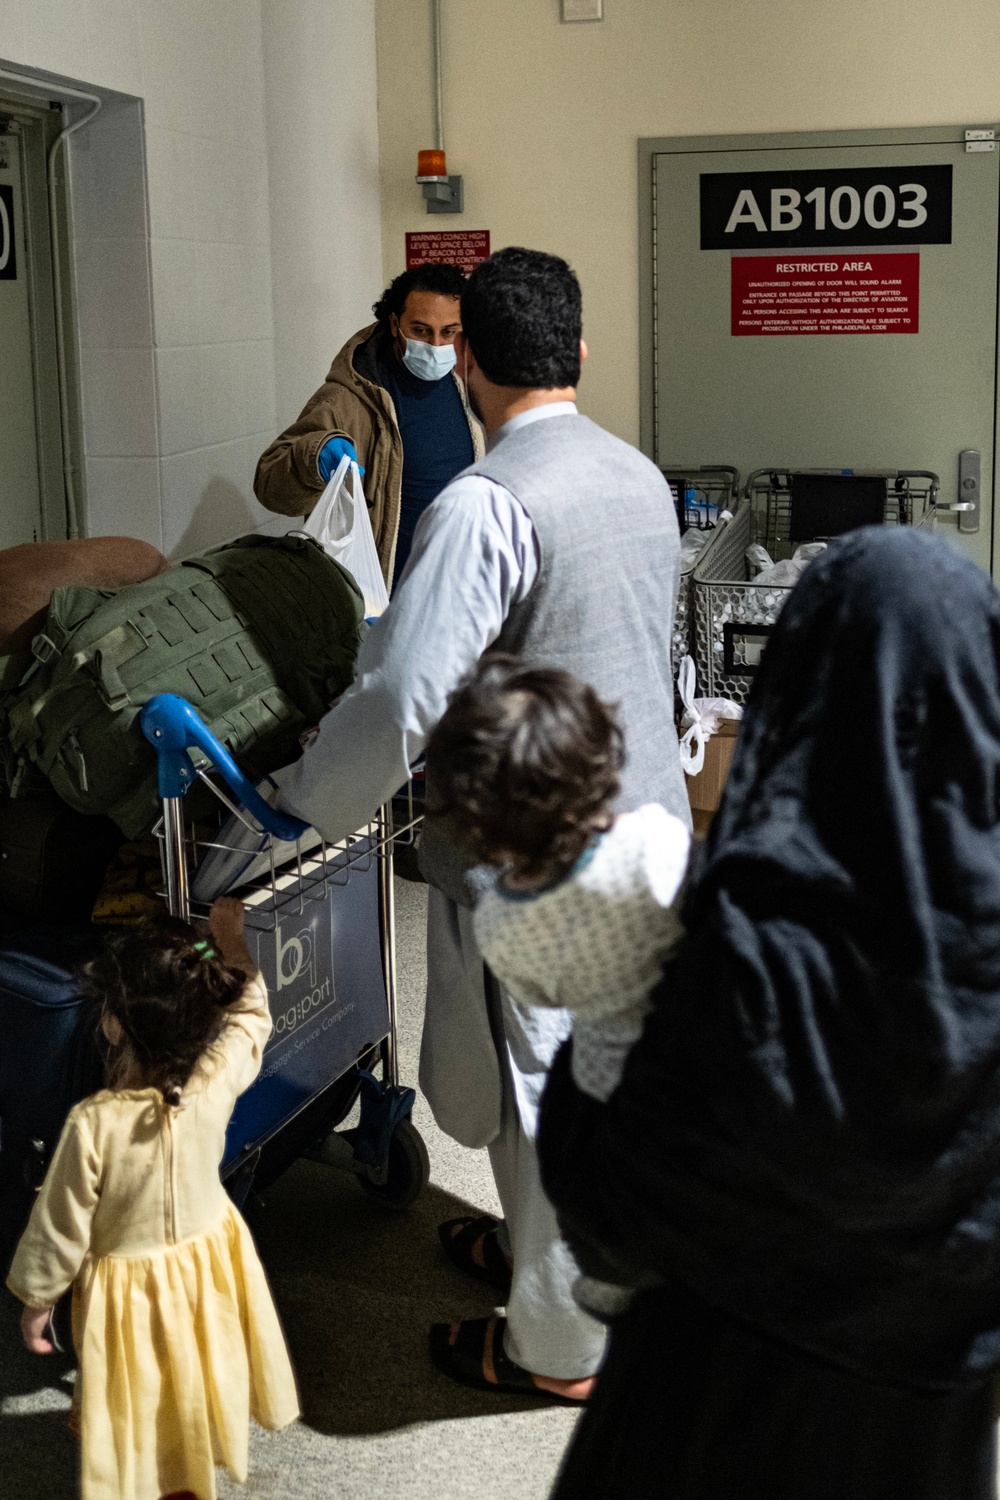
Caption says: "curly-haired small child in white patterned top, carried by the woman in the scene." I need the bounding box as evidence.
[427,653,691,1101]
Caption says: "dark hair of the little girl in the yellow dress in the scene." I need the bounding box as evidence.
[79,917,246,1104]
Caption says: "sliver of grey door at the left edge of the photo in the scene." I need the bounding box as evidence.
[0,135,43,548]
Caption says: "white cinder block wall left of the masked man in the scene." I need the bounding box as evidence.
[0,0,381,557]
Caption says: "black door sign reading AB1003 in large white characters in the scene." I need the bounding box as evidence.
[700,167,952,251]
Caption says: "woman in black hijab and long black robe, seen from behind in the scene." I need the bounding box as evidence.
[540,528,1000,1500]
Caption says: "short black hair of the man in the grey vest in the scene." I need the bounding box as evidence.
[462,246,583,390]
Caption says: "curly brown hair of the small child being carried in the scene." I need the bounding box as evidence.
[426,651,625,881]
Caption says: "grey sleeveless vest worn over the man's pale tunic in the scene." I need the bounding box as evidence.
[421,413,691,906]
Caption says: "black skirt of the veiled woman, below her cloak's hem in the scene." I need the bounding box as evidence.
[552,1286,997,1500]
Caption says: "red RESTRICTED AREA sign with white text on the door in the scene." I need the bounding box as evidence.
[732,251,921,338]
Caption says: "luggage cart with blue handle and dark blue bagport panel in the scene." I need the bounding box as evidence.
[141,693,429,1208]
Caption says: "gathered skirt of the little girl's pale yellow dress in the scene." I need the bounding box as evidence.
[73,1205,298,1500]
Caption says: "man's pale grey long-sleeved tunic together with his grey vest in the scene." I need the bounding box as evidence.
[279,404,690,1146]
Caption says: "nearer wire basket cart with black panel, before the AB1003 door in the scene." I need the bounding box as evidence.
[690,470,954,704]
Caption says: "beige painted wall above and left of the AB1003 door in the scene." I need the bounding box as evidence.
[376,0,1000,443]
